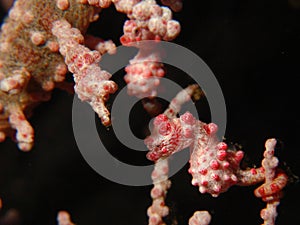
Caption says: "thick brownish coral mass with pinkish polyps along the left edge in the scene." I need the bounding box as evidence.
[0,0,95,150]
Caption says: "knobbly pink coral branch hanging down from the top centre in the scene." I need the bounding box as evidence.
[120,0,180,98]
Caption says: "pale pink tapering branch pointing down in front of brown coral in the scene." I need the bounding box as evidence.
[52,20,117,126]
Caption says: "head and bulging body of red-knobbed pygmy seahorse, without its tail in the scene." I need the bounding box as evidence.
[146,112,243,196]
